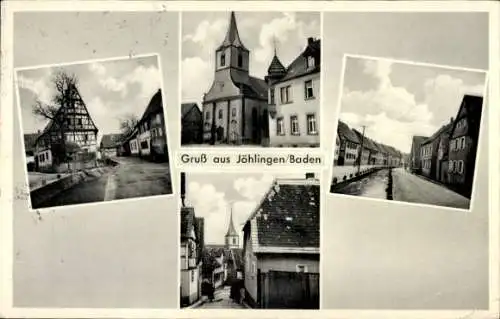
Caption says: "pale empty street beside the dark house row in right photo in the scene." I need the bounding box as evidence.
[392,168,470,209]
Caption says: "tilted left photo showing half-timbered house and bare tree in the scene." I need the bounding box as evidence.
[16,55,172,209]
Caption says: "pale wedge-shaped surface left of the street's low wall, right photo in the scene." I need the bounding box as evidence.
[335,169,388,199]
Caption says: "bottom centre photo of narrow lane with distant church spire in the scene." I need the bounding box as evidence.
[179,172,320,309]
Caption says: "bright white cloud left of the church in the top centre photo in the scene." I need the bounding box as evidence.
[181,57,213,105]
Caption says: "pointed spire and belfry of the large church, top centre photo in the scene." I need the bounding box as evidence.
[215,12,250,74]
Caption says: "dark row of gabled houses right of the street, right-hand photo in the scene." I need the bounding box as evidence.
[410,95,483,198]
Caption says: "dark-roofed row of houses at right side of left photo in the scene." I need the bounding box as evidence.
[118,89,168,162]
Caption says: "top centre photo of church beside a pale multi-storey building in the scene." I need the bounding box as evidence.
[181,12,321,147]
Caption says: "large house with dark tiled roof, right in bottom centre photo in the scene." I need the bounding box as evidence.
[243,174,320,308]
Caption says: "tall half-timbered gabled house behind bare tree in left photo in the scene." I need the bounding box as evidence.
[34,85,99,170]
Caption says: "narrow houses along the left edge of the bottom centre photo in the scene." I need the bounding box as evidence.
[180,173,204,307]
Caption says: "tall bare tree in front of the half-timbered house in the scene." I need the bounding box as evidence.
[32,70,78,170]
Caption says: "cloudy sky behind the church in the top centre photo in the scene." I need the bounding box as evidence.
[181,12,320,104]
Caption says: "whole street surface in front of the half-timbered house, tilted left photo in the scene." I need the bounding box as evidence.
[41,157,172,207]
